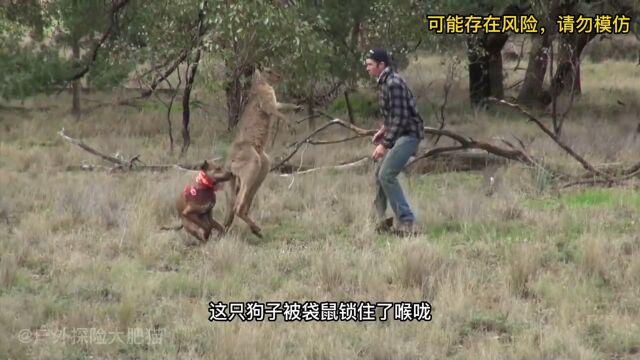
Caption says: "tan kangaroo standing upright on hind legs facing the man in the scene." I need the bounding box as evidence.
[224,69,301,238]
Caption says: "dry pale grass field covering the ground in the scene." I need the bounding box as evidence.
[0,48,640,359]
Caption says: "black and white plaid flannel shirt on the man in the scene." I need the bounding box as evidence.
[378,67,424,149]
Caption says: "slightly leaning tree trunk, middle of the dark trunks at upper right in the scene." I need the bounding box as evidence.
[518,33,551,106]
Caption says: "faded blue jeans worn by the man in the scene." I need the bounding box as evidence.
[374,136,420,223]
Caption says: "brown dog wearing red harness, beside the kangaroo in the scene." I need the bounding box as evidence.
[163,161,232,242]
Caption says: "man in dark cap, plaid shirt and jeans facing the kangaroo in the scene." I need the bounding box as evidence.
[365,49,424,235]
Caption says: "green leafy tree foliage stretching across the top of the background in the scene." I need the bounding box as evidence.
[0,0,639,107]
